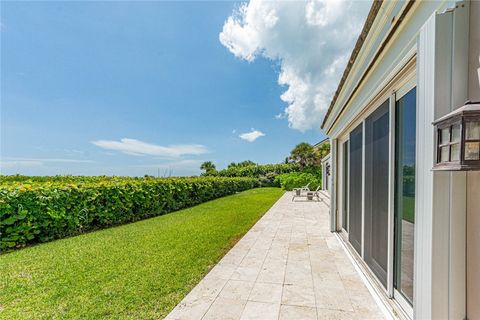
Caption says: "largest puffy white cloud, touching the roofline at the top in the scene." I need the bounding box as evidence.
[219,0,371,131]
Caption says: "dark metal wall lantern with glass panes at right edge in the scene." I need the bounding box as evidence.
[433,101,480,171]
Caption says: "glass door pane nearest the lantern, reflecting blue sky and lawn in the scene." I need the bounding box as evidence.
[394,88,416,305]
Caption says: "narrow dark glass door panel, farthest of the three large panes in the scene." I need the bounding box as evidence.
[348,124,363,254]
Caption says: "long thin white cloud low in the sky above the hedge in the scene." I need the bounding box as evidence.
[92,138,208,157]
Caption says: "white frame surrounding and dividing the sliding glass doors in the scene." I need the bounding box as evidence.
[335,49,418,319]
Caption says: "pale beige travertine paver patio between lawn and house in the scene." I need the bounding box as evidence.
[167,193,384,320]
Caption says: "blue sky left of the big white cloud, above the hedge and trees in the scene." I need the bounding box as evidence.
[1,2,368,175]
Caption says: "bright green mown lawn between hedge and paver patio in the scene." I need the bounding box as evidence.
[0,188,283,319]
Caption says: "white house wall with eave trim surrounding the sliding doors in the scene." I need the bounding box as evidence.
[325,1,480,320]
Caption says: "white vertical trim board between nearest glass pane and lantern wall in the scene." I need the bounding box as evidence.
[413,15,436,319]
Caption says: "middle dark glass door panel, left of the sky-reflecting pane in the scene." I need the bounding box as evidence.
[364,100,390,287]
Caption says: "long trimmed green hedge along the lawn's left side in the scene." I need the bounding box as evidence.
[0,176,259,253]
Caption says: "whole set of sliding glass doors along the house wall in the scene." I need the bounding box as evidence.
[341,84,416,313]
